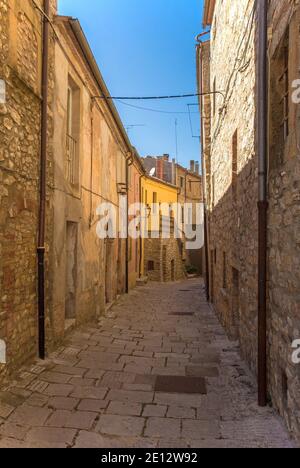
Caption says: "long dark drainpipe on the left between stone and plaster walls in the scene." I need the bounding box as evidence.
[37,0,50,359]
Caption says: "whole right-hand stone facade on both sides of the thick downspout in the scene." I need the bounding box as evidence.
[197,0,300,442]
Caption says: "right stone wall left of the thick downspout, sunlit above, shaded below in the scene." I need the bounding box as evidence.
[206,0,257,352]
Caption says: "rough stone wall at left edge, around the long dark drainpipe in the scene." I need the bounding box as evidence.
[0,0,56,376]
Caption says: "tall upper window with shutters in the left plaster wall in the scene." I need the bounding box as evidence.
[65,78,80,185]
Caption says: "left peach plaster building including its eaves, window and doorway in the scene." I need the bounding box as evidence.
[52,16,132,338]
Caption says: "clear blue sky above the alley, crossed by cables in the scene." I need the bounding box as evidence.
[59,0,203,165]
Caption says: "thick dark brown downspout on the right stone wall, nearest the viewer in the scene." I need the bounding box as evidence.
[257,0,269,407]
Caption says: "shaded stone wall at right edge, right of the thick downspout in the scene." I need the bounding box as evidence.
[268,0,300,437]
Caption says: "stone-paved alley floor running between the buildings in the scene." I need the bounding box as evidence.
[0,280,293,448]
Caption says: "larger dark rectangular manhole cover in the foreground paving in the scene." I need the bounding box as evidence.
[154,375,207,395]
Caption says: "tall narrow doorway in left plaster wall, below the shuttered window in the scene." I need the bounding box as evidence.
[65,222,78,320]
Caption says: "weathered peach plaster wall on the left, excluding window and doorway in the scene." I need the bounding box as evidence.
[53,19,126,338]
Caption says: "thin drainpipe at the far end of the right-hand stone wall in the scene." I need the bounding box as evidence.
[197,42,210,301]
